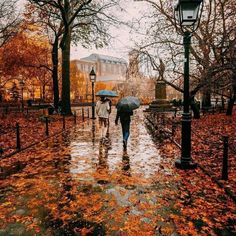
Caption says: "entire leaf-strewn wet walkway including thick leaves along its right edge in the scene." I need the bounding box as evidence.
[0,108,236,236]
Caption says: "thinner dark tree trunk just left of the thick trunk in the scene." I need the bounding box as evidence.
[52,36,59,110]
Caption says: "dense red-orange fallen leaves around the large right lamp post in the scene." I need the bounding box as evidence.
[148,111,236,236]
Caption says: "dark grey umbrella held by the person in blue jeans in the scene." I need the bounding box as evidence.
[116,96,140,112]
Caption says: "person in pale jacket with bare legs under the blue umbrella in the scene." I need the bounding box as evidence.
[96,97,110,139]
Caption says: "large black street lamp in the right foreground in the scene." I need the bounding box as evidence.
[175,0,203,169]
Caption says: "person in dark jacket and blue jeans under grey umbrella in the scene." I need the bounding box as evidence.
[115,109,133,152]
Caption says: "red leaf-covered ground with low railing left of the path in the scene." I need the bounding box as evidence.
[0,108,89,159]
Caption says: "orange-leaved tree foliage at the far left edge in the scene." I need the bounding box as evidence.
[0,28,51,99]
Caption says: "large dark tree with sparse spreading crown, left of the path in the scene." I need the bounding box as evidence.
[27,0,122,114]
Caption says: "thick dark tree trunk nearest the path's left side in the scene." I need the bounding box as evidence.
[61,29,72,115]
